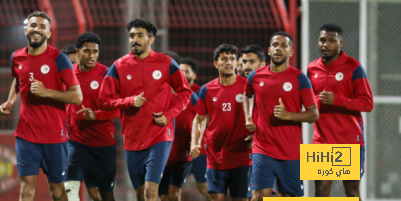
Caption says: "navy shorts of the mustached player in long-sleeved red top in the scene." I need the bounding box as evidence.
[125,141,172,189]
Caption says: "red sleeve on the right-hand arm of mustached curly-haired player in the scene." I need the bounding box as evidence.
[163,59,192,122]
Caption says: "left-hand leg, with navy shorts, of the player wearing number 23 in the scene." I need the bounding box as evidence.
[206,168,230,201]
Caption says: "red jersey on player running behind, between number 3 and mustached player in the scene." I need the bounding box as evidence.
[67,62,120,147]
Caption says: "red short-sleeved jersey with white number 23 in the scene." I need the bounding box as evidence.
[197,76,252,169]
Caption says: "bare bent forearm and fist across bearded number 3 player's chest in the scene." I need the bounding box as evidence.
[31,79,83,105]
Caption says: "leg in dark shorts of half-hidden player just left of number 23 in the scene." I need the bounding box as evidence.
[168,161,192,201]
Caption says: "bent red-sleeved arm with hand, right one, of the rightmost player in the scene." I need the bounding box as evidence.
[319,65,373,112]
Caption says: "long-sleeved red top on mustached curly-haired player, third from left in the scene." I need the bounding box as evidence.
[98,50,192,151]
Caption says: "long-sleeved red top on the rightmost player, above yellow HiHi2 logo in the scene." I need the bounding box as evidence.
[308,51,373,146]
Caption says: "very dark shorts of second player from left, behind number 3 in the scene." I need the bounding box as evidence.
[66,140,117,192]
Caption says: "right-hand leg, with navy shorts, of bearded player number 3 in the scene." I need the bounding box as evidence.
[41,142,68,201]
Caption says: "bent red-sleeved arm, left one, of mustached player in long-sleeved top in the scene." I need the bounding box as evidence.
[97,64,146,110]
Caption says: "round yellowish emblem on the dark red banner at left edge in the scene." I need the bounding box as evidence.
[0,145,19,194]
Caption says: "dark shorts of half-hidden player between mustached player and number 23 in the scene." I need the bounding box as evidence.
[159,161,192,195]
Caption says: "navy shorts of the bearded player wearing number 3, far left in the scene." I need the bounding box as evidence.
[15,137,67,183]
